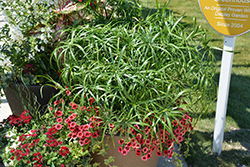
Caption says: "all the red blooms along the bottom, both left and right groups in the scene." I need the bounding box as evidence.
[4,94,193,166]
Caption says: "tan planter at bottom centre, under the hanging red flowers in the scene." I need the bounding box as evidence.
[92,136,159,167]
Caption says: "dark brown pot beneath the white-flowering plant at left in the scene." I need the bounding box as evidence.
[4,84,58,115]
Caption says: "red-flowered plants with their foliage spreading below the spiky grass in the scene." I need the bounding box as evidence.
[2,91,193,166]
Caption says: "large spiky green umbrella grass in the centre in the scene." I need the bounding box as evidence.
[47,4,216,164]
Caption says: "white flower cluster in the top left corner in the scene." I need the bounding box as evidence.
[0,0,60,52]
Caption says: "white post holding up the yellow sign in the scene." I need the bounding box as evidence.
[213,36,236,155]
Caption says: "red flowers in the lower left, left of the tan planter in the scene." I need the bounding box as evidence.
[4,98,102,167]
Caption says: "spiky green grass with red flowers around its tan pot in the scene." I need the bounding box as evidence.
[2,1,215,166]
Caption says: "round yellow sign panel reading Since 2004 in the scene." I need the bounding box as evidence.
[198,0,250,36]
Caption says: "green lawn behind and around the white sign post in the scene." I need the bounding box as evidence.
[139,0,250,167]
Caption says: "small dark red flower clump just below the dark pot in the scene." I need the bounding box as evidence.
[7,110,32,126]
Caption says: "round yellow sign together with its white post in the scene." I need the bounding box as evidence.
[198,0,250,155]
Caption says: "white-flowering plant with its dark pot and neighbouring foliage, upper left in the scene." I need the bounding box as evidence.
[0,0,141,115]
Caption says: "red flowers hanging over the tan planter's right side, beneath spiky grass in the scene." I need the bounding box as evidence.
[118,113,193,161]
